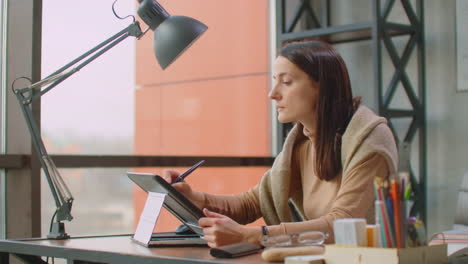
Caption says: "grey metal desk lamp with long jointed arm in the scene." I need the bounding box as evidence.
[12,0,207,239]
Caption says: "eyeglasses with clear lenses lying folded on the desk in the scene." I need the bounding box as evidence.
[260,231,328,247]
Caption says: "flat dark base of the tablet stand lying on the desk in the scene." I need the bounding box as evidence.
[147,232,208,247]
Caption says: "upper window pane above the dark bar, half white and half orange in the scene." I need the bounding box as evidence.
[42,0,271,156]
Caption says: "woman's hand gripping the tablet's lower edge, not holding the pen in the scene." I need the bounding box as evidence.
[198,208,261,247]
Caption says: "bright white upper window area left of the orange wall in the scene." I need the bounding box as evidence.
[41,0,135,154]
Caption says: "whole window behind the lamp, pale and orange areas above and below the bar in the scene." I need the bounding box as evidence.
[41,0,271,235]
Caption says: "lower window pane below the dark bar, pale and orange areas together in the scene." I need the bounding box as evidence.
[41,167,268,236]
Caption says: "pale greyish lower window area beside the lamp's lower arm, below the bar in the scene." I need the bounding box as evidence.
[41,168,134,236]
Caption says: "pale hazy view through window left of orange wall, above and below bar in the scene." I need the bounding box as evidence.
[41,0,136,236]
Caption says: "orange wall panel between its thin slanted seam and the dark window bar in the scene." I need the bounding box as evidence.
[135,76,270,156]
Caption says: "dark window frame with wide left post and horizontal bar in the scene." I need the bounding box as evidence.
[0,0,276,239]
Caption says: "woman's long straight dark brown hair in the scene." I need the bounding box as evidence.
[279,41,360,181]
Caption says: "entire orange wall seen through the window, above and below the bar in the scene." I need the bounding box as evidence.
[134,0,270,231]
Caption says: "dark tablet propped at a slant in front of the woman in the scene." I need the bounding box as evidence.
[127,172,203,237]
